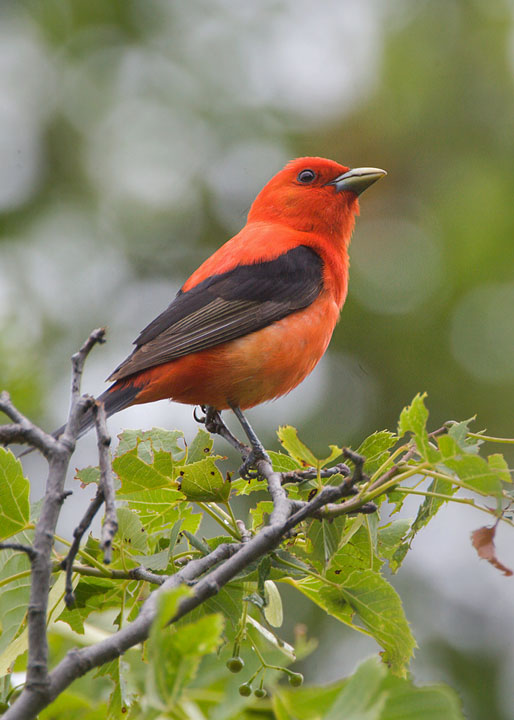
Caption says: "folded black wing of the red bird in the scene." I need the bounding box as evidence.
[109,245,323,380]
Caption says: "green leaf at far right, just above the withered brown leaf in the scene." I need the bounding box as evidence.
[438,435,502,496]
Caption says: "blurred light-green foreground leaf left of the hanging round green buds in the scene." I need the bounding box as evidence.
[146,588,223,711]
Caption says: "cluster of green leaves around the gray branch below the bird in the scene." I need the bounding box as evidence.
[0,396,514,720]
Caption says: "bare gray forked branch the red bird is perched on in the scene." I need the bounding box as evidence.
[0,330,380,720]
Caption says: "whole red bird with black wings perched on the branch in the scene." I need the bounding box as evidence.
[74,157,386,470]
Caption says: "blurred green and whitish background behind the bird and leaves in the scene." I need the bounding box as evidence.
[0,0,514,720]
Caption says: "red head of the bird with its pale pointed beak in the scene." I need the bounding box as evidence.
[248,157,386,242]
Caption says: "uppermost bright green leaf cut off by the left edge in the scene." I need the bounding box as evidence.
[0,447,30,540]
